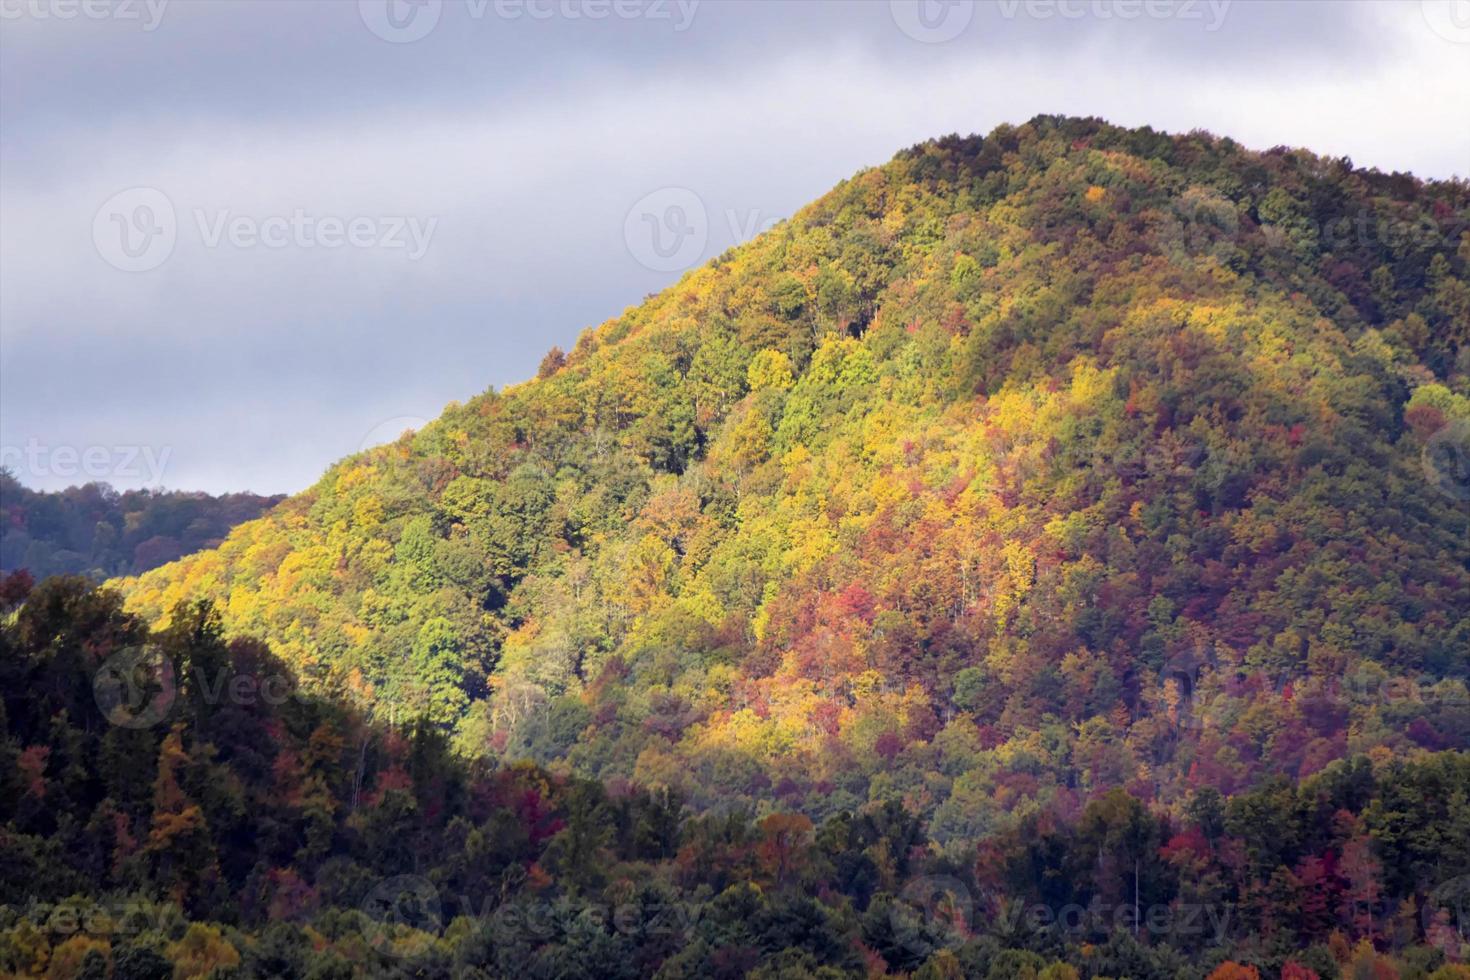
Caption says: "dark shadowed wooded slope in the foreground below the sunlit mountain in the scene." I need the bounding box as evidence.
[0,576,1470,980]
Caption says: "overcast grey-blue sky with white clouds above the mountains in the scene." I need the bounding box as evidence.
[0,0,1470,492]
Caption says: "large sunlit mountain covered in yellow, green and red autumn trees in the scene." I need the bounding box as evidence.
[122,118,1470,840]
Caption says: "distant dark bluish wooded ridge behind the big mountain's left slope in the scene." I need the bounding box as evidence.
[0,470,284,580]
